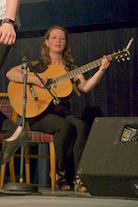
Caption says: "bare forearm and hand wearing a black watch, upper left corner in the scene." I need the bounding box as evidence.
[0,0,18,45]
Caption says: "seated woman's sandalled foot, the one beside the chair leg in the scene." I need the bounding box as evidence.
[56,172,70,191]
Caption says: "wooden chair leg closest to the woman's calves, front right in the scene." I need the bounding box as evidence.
[50,142,56,190]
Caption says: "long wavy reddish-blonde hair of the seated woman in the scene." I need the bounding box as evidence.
[40,26,74,67]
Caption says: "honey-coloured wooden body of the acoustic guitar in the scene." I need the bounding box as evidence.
[8,65,73,118]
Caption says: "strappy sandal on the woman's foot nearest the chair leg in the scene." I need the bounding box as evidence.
[56,172,70,190]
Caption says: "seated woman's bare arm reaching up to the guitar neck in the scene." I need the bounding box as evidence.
[74,58,110,93]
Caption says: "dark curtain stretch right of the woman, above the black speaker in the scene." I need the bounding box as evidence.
[70,28,138,121]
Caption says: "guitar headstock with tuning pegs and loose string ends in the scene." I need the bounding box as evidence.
[111,38,133,62]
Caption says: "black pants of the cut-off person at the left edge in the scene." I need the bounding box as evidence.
[0,35,17,139]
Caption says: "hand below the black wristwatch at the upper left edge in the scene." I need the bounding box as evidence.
[0,22,16,45]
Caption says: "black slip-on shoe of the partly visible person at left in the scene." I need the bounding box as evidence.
[0,129,30,165]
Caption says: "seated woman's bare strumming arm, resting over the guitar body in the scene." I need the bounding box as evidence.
[6,65,47,87]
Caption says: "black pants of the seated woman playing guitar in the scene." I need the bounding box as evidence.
[30,114,88,173]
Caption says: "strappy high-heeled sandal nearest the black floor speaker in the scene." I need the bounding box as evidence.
[73,175,87,192]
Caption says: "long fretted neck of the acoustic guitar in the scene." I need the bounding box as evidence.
[56,55,112,84]
